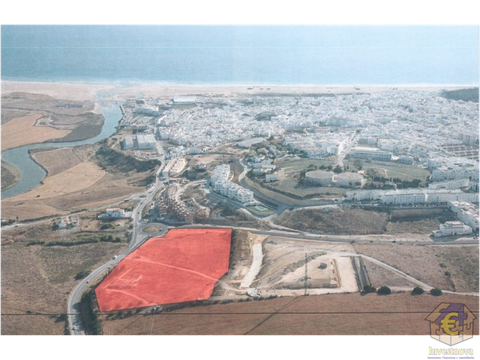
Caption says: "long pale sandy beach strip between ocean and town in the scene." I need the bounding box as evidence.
[0,81,473,101]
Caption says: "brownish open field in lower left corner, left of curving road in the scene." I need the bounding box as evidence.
[0,235,126,336]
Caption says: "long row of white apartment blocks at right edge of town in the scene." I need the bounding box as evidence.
[346,188,480,205]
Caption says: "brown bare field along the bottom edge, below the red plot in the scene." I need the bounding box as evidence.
[104,294,480,337]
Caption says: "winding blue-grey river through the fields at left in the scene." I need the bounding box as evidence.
[0,101,122,200]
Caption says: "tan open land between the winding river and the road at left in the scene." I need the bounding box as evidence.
[0,146,156,220]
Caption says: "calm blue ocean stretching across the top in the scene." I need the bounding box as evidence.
[0,24,479,85]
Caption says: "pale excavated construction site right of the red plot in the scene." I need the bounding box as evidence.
[214,231,362,298]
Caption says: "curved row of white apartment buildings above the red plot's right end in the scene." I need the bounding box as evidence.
[210,165,255,204]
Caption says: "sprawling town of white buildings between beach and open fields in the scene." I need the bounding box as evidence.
[114,88,480,236]
